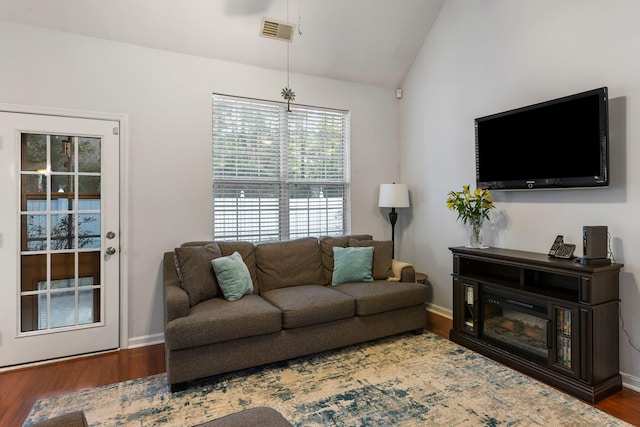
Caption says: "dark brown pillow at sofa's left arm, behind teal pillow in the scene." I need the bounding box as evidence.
[174,243,222,307]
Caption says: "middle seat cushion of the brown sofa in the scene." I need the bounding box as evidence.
[262,285,355,329]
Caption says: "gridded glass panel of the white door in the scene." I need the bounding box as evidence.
[20,134,102,332]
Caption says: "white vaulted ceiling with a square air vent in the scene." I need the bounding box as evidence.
[0,0,445,88]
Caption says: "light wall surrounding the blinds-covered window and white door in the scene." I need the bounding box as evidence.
[0,23,400,345]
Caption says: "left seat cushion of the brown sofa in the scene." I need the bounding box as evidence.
[165,295,282,350]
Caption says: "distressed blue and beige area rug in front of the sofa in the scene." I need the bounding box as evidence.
[25,333,629,426]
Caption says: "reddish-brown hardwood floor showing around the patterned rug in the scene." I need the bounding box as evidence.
[0,313,640,427]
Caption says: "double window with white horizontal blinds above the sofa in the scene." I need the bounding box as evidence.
[213,95,349,243]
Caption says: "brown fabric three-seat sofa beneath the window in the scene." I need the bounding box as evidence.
[163,235,427,391]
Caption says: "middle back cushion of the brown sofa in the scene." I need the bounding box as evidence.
[256,237,326,294]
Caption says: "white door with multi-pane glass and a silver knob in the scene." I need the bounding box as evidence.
[0,112,120,367]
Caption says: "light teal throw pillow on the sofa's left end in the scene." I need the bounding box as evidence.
[211,251,253,301]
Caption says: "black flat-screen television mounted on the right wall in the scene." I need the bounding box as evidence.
[475,87,609,190]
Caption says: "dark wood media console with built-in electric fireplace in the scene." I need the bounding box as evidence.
[449,247,623,403]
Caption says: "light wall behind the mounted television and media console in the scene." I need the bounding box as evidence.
[401,0,640,389]
